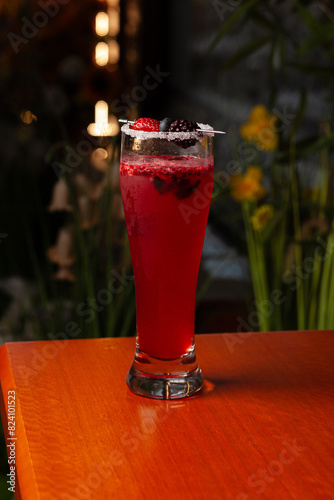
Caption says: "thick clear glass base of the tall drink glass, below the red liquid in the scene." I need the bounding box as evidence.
[126,345,203,399]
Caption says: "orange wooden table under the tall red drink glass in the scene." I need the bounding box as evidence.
[0,331,334,500]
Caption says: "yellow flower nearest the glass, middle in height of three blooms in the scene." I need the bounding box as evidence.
[230,166,267,202]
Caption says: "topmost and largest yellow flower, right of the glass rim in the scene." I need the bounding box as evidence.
[240,104,278,151]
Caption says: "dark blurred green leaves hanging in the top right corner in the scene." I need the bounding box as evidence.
[209,0,334,108]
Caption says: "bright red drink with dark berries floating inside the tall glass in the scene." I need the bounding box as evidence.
[120,156,213,359]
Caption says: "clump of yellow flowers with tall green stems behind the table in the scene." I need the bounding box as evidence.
[226,106,334,331]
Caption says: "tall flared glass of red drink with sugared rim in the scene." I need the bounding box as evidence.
[120,124,214,399]
